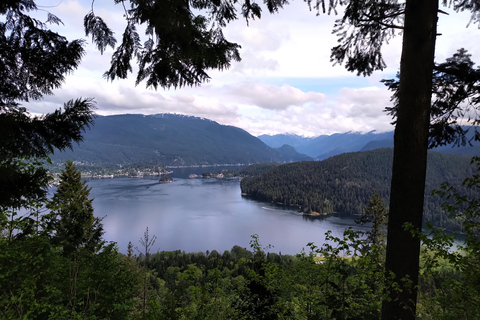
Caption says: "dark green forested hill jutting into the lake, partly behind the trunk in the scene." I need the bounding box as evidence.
[241,148,475,229]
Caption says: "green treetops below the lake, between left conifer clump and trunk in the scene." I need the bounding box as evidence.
[136,230,390,319]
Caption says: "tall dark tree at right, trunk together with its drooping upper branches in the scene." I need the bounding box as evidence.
[310,0,480,319]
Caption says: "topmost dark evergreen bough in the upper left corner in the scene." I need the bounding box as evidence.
[0,0,84,105]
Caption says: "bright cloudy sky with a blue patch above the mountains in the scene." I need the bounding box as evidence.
[29,0,480,137]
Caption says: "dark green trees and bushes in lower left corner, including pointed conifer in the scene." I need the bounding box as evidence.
[0,162,140,319]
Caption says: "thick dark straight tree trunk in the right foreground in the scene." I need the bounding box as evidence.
[382,0,438,320]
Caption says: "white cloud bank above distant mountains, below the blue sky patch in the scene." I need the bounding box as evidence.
[221,87,393,136]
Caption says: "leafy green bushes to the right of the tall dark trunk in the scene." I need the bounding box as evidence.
[410,158,480,319]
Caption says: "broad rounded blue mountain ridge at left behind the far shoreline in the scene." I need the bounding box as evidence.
[52,114,310,166]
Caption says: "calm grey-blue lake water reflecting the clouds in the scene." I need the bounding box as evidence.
[87,169,370,254]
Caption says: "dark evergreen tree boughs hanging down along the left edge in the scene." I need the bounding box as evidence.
[0,0,94,211]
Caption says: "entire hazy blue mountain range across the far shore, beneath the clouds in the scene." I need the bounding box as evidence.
[51,114,480,166]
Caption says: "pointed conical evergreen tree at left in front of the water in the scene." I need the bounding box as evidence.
[49,161,103,255]
